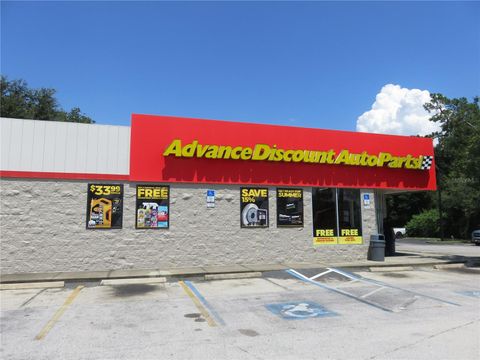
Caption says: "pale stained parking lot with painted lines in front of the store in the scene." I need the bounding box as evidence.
[0,267,480,359]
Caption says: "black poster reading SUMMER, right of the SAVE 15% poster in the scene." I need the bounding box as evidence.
[277,189,303,227]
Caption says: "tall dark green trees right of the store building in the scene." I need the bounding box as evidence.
[387,94,480,239]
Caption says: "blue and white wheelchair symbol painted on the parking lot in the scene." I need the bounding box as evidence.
[265,301,338,320]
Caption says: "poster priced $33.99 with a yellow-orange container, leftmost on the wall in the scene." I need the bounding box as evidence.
[87,184,123,229]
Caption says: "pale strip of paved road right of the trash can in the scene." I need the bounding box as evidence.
[396,239,480,257]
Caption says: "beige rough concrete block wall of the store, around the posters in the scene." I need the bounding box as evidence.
[0,179,377,274]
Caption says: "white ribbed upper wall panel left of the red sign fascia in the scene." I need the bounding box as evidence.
[0,118,130,175]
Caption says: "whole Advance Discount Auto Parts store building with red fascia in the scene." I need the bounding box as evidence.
[0,115,436,274]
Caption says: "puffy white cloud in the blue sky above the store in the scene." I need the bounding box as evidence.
[357,84,439,135]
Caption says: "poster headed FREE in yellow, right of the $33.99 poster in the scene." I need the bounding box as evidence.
[135,185,170,229]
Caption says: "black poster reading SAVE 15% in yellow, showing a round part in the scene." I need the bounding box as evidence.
[240,188,268,228]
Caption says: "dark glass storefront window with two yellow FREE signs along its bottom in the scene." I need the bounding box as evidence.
[312,188,362,245]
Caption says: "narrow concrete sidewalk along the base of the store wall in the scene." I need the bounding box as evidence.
[0,253,480,284]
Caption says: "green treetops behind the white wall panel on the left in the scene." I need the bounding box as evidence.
[0,76,94,123]
